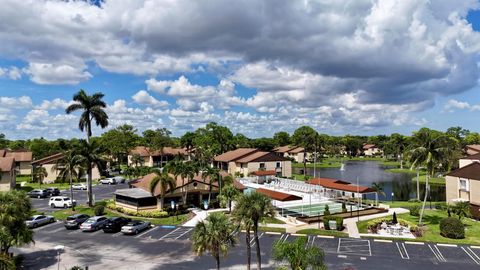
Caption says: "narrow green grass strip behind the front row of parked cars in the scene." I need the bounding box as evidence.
[43,205,190,225]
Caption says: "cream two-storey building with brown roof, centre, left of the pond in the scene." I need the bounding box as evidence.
[214,148,292,177]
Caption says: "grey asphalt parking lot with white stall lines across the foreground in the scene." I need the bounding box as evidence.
[14,222,480,269]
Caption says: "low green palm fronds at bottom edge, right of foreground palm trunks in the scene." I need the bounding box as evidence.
[272,236,327,270]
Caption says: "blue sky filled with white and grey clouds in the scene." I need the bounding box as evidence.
[0,0,480,139]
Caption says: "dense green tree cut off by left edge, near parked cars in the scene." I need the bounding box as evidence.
[0,190,33,258]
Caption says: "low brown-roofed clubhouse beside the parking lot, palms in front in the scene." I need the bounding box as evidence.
[114,173,226,211]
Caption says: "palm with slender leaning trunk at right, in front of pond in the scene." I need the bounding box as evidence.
[408,128,458,224]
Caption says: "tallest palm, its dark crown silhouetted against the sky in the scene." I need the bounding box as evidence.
[65,89,108,206]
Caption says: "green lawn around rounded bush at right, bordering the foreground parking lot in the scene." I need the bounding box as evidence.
[357,210,480,245]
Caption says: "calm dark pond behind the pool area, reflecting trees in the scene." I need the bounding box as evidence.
[293,161,445,201]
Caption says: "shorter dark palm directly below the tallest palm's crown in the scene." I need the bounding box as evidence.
[75,140,104,207]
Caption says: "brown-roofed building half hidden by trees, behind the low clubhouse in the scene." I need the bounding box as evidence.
[128,146,188,167]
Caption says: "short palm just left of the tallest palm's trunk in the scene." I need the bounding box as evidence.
[52,151,82,211]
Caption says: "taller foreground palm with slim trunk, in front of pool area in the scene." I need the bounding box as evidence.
[234,192,273,269]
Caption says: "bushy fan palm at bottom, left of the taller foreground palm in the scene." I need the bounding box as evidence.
[192,212,236,269]
